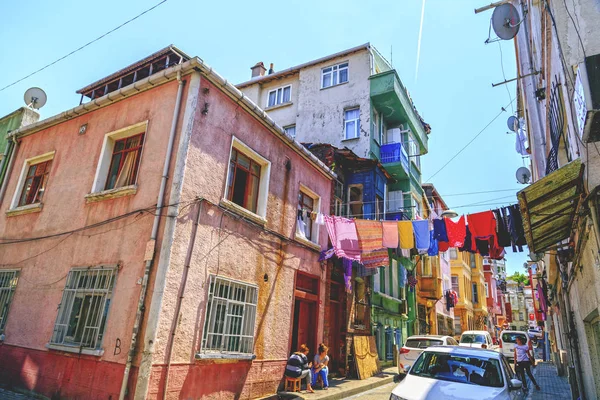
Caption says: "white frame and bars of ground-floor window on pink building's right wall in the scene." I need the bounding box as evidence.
[202,274,259,359]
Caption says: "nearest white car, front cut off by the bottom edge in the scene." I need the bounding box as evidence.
[390,346,525,400]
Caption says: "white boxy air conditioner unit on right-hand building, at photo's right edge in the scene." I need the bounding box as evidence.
[573,54,600,143]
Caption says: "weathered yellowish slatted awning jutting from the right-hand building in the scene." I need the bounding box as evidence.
[517,159,584,253]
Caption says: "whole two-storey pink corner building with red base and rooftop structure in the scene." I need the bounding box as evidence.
[0,46,334,399]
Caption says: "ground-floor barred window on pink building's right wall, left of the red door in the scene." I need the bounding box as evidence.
[202,275,258,354]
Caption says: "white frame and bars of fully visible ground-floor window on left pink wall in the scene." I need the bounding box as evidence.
[46,265,118,356]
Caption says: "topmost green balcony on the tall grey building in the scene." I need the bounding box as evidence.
[369,70,427,154]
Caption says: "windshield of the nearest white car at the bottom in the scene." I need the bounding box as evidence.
[410,351,504,387]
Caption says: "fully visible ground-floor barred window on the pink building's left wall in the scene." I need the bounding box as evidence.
[49,267,117,350]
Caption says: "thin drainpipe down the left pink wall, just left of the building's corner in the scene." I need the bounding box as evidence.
[119,71,185,400]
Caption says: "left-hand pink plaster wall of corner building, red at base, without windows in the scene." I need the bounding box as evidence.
[0,76,190,399]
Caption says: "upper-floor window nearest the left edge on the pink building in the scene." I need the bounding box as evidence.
[10,152,54,209]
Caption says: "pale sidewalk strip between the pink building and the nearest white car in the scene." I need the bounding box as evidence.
[272,367,398,400]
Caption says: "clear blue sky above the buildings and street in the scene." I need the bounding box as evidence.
[0,0,526,272]
